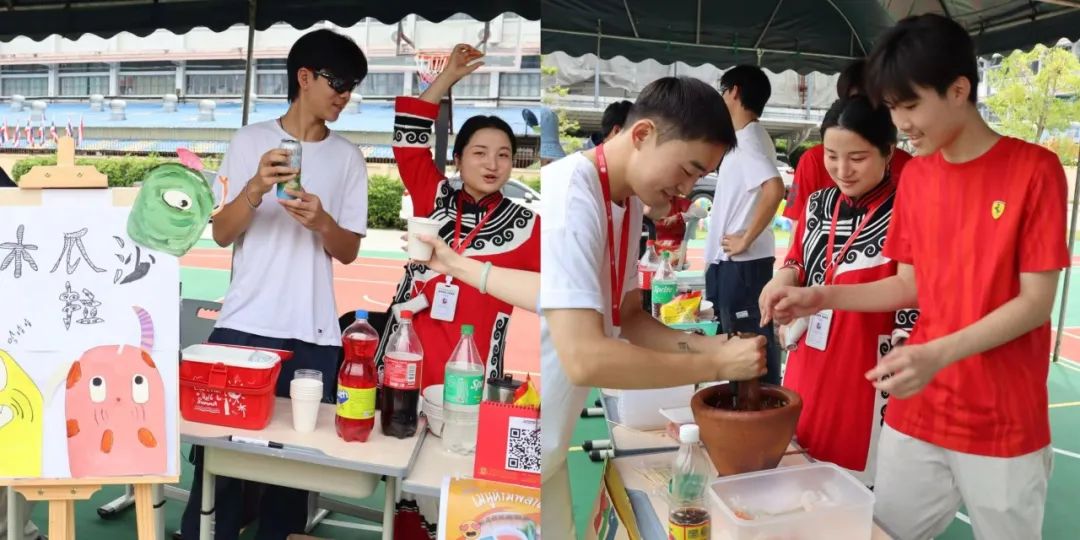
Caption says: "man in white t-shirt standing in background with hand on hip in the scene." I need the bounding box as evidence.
[705,66,784,384]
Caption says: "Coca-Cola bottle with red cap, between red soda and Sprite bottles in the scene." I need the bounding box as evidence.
[379,311,423,438]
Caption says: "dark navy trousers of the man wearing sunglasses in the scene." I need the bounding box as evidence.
[180,328,341,540]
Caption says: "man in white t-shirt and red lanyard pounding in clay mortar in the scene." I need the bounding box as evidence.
[540,77,765,539]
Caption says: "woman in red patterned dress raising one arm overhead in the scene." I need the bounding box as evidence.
[376,44,540,389]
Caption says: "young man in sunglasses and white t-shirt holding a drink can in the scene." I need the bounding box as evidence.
[183,30,367,540]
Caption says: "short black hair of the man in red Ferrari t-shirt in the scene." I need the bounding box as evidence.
[866,13,978,103]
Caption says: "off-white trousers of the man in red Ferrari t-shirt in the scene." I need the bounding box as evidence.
[874,426,1053,540]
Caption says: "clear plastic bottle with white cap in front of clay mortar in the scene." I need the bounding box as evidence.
[667,423,712,540]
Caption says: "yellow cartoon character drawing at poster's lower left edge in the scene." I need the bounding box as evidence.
[0,350,44,478]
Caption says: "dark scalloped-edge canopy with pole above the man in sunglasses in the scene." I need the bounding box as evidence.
[0,0,540,170]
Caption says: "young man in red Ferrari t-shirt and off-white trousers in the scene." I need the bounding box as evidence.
[762,15,1069,540]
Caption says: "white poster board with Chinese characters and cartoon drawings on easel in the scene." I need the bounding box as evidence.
[0,189,180,482]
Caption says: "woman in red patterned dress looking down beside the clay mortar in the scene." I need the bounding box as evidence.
[761,96,918,485]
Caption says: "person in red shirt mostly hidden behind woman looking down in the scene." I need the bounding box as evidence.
[783,58,912,225]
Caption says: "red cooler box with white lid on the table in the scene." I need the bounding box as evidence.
[180,343,293,431]
